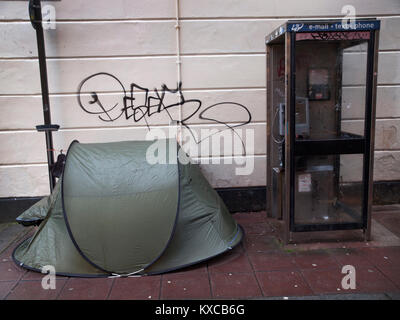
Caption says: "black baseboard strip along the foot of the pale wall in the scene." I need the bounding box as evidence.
[0,181,400,223]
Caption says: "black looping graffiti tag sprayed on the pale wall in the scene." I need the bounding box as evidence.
[77,72,251,146]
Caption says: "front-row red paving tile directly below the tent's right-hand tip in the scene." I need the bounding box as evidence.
[210,273,262,299]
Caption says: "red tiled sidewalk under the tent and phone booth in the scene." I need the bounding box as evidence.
[0,206,400,300]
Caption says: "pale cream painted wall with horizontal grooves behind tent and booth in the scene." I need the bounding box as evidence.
[0,0,400,197]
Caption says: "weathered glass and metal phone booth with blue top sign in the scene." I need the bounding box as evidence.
[266,19,380,243]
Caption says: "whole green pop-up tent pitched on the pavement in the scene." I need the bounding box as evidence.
[13,140,243,277]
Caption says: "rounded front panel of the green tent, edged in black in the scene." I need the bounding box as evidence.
[61,140,180,275]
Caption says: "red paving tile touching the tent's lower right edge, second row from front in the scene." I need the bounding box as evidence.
[208,252,253,273]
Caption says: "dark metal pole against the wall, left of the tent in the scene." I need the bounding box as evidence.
[29,0,59,192]
